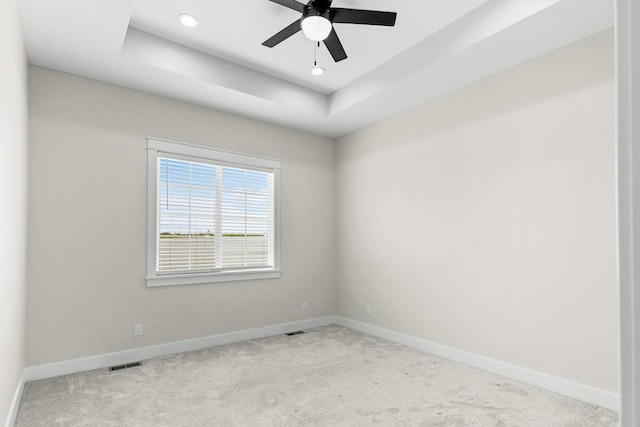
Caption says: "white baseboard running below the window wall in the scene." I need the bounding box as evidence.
[23,316,336,382]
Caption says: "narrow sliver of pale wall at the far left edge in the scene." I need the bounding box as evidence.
[0,0,27,423]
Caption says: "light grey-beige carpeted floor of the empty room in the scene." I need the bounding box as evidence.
[16,326,617,427]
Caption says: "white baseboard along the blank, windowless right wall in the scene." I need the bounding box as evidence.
[336,316,620,412]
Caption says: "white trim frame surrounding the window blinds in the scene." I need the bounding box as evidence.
[146,137,281,287]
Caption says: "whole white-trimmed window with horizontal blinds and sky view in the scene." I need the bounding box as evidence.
[147,138,280,286]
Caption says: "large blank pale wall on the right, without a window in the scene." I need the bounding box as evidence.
[336,31,619,393]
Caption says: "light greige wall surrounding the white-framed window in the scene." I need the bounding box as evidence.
[27,67,337,366]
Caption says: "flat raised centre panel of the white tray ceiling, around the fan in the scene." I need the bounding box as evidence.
[129,0,488,94]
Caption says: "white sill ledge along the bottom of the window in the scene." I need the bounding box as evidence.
[146,270,281,288]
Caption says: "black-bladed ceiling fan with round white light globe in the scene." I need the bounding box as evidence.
[262,0,397,62]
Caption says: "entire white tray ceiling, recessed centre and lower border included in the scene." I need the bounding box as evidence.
[19,0,613,137]
